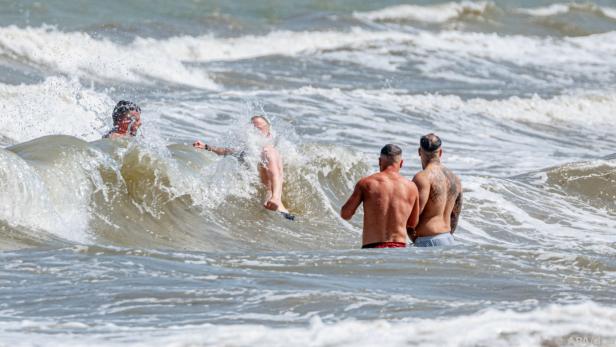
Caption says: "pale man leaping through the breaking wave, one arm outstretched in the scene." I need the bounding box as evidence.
[193,115,295,220]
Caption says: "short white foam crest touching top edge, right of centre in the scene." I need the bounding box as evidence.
[354,1,491,23]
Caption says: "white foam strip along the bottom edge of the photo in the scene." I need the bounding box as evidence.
[0,302,616,347]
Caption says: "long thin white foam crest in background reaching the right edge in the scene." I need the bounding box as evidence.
[146,24,616,75]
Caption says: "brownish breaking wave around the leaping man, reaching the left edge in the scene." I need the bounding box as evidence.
[0,136,368,250]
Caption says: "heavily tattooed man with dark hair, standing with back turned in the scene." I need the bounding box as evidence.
[411,134,462,247]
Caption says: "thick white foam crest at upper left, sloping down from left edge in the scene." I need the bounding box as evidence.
[0,26,216,89]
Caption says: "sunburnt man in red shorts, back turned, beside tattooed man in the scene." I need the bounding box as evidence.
[340,144,419,248]
